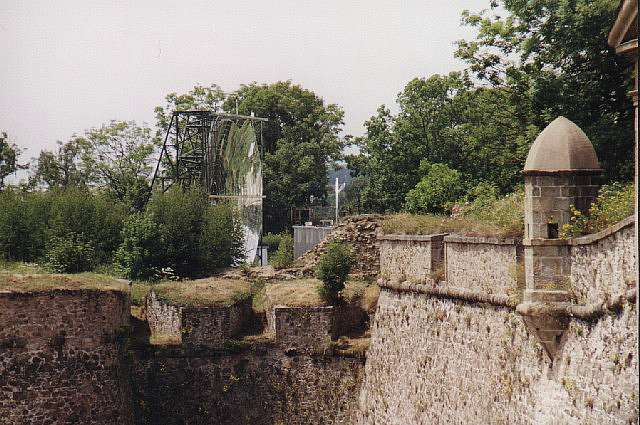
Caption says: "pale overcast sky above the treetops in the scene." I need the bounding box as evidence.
[0,0,489,158]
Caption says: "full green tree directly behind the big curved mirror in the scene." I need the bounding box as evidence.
[223,81,344,219]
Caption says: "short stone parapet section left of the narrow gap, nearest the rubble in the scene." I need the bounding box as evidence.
[378,234,446,279]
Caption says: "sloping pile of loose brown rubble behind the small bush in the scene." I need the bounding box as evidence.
[283,214,384,278]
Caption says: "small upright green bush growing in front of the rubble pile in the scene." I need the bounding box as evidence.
[316,241,354,303]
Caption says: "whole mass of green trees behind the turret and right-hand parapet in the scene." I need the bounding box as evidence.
[348,0,633,213]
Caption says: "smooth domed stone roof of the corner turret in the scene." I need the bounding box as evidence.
[524,117,600,172]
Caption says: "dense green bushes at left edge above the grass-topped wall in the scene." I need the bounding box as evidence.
[0,188,126,272]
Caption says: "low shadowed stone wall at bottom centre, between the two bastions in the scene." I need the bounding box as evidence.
[134,345,363,425]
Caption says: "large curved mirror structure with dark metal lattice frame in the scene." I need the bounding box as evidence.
[151,111,267,262]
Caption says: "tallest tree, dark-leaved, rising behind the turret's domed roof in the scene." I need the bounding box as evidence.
[456,0,633,179]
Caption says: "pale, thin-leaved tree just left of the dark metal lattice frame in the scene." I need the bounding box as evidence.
[81,121,157,210]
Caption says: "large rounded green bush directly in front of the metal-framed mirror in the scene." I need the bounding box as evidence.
[115,189,244,280]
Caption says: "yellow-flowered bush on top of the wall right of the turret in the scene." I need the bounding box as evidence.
[559,182,635,239]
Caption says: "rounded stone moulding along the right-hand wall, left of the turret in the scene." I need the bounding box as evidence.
[378,279,515,309]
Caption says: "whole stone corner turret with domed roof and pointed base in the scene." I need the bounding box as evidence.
[523,117,601,358]
